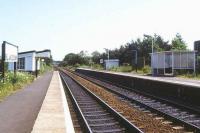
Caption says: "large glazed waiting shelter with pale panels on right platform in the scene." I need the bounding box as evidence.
[151,51,196,75]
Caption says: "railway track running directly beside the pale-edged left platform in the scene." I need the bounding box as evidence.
[60,72,142,133]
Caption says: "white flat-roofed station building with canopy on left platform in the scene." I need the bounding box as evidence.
[8,50,51,72]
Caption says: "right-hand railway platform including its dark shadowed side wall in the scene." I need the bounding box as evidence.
[76,68,200,106]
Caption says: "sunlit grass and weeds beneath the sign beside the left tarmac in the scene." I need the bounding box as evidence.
[0,72,34,101]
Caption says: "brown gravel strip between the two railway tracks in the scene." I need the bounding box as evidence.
[64,70,181,133]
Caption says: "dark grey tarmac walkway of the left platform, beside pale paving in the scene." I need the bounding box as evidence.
[0,72,52,133]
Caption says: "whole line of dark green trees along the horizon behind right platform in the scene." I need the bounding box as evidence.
[60,33,187,67]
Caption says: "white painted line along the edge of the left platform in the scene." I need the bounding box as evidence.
[57,73,75,133]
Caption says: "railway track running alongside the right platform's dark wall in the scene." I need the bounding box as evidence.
[74,70,200,132]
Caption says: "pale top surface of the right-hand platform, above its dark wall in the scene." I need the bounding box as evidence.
[77,68,200,88]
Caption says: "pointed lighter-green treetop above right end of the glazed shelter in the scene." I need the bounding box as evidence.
[172,33,187,50]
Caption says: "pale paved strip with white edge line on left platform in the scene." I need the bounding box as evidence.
[32,71,74,133]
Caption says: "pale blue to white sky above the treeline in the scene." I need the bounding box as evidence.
[0,0,200,60]
